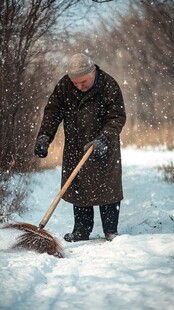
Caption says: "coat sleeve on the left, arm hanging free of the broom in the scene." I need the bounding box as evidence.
[38,82,64,142]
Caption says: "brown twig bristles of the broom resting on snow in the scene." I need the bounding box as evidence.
[4,223,63,258]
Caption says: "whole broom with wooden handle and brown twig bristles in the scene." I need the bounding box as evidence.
[3,145,94,258]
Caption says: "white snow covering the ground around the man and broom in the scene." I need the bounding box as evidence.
[0,147,174,310]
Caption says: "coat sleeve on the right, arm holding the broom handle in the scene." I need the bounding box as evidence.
[102,81,126,141]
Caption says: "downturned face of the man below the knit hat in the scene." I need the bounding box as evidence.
[71,69,96,92]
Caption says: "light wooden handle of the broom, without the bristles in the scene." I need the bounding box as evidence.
[39,145,94,228]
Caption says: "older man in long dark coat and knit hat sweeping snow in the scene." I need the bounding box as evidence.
[35,54,126,242]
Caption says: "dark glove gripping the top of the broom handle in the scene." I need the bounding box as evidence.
[84,135,109,157]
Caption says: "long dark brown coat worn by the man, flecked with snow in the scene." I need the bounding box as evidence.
[39,66,126,206]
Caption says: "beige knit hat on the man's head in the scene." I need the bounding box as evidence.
[67,54,95,78]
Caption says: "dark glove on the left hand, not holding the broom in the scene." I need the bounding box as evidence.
[34,135,50,158]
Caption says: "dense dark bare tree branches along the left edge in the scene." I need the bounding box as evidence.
[0,0,81,170]
